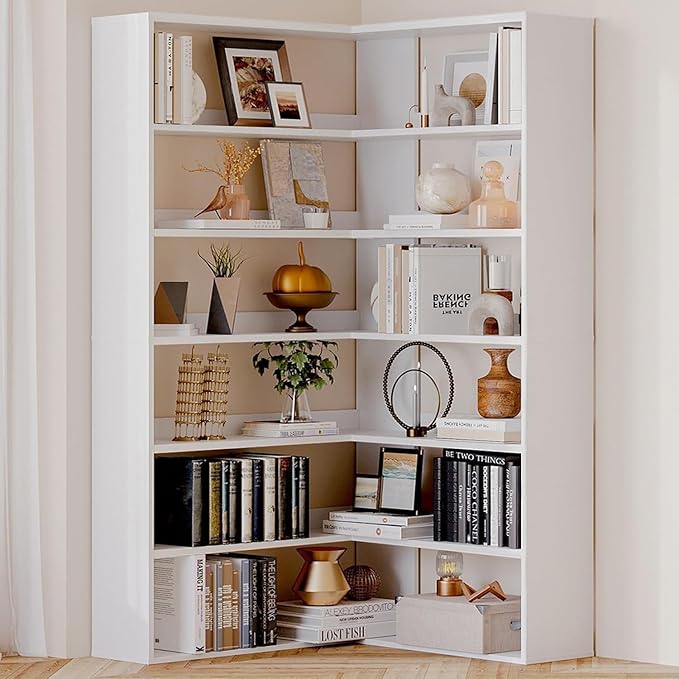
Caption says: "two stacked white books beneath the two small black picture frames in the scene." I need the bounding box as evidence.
[323,511,434,540]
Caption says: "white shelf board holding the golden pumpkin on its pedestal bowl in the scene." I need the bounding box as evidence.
[153,330,522,347]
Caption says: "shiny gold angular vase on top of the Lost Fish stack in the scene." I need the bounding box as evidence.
[292,546,349,606]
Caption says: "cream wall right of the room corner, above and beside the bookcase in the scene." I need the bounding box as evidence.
[363,0,679,665]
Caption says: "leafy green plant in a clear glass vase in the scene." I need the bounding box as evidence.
[252,340,339,422]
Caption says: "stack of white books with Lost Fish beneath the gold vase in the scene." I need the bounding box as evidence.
[278,599,396,644]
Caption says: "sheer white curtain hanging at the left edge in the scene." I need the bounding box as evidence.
[0,0,47,656]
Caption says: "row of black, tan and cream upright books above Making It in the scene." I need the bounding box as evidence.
[155,453,309,547]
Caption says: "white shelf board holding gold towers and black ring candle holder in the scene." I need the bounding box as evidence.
[153,431,522,455]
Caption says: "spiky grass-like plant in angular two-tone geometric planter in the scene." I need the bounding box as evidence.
[198,243,246,335]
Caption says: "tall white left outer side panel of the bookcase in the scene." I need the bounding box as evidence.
[92,14,153,663]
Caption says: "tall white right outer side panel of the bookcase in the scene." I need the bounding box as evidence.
[522,14,594,663]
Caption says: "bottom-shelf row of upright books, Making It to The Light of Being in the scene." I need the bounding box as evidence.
[153,553,277,653]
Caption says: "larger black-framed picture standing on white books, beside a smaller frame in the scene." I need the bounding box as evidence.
[379,448,422,514]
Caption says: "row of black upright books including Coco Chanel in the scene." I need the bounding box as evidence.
[433,450,521,549]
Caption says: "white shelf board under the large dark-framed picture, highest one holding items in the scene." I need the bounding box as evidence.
[153,123,522,142]
